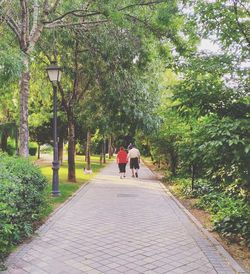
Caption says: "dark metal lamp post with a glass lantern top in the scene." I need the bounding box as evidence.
[47,62,61,196]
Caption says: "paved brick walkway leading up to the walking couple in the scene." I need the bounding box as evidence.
[2,164,246,274]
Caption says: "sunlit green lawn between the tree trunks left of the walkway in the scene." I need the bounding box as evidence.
[37,155,112,211]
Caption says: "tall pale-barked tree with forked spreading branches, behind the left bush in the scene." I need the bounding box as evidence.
[0,0,176,157]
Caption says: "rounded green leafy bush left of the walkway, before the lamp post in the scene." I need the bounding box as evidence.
[0,155,47,262]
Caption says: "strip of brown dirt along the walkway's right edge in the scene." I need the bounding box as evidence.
[143,160,250,273]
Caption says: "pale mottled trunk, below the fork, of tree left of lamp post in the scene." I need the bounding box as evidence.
[19,53,30,157]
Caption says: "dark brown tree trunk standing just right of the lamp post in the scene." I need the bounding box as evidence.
[68,117,76,182]
